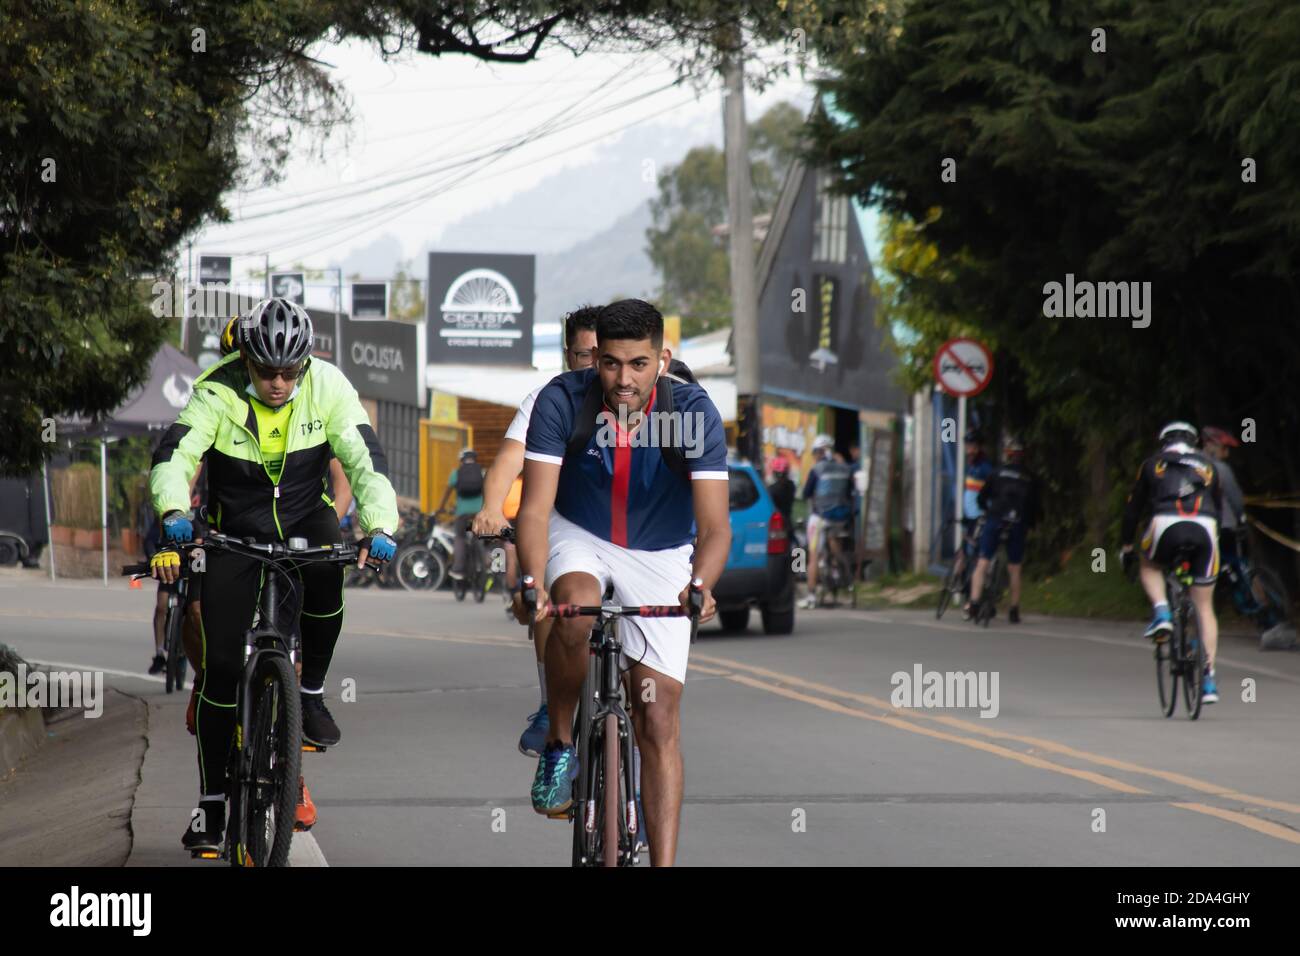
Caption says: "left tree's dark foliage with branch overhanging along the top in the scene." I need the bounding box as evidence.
[0,0,806,473]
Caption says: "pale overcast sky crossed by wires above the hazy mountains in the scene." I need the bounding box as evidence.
[191,43,832,283]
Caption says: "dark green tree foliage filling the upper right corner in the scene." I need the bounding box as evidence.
[803,0,1300,564]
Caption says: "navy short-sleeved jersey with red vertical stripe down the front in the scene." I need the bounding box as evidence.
[524,368,727,551]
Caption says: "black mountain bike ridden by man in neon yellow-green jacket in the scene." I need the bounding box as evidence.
[122,532,371,866]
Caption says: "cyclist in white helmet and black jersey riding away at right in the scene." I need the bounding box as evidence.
[1119,421,1223,704]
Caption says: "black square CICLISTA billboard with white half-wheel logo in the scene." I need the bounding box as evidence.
[428,252,537,367]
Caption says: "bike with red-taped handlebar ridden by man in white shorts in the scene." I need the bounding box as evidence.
[524,578,705,866]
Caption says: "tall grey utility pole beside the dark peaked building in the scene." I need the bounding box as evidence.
[723,23,762,467]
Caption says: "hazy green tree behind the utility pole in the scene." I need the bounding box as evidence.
[646,103,803,336]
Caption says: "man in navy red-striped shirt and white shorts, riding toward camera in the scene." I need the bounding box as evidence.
[516,299,731,866]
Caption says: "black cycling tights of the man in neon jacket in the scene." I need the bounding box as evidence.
[195,507,343,793]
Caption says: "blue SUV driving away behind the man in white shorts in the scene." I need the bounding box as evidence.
[714,459,794,633]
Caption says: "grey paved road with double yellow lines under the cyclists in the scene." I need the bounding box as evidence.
[0,572,1300,866]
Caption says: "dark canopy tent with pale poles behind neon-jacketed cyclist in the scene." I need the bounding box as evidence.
[46,343,199,587]
